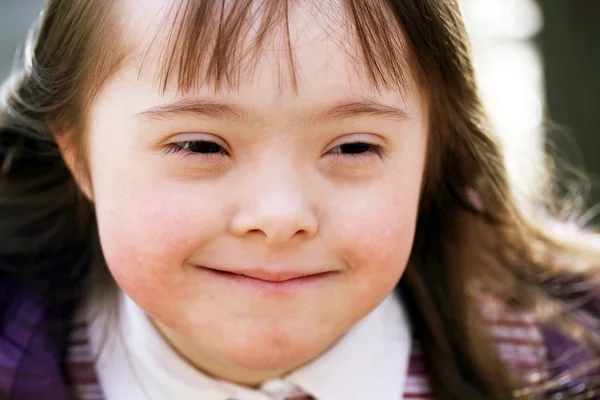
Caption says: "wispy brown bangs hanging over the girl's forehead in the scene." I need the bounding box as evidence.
[142,0,416,94]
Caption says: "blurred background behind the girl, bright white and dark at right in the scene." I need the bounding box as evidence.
[0,0,600,223]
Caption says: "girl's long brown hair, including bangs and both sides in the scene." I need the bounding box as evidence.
[0,0,600,399]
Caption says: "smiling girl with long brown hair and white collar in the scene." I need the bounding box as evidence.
[0,0,600,400]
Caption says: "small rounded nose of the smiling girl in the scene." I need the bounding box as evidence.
[230,162,318,244]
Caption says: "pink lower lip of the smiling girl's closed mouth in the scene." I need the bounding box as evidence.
[199,267,335,292]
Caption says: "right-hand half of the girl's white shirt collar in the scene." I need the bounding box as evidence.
[286,294,412,400]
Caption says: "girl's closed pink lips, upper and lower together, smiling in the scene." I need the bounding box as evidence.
[199,267,336,292]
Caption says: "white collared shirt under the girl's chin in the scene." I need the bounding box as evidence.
[89,294,411,400]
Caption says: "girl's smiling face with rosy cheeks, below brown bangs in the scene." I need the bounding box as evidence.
[79,0,427,383]
